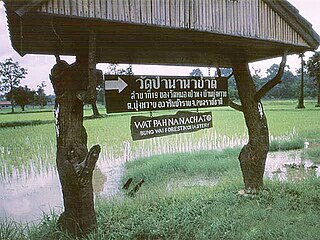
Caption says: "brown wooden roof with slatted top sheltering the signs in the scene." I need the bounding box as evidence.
[5,0,320,66]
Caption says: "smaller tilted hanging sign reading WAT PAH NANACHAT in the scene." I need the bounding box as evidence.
[131,112,212,140]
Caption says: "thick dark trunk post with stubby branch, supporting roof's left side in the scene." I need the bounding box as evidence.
[51,58,100,236]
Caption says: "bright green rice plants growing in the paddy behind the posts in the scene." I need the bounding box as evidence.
[0,101,320,178]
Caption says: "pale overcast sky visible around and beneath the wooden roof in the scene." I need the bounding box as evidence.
[0,0,320,94]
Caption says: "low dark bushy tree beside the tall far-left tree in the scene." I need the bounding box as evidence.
[6,86,35,111]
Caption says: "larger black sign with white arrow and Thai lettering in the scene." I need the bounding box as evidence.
[105,75,228,113]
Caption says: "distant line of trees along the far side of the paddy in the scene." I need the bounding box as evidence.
[0,51,320,114]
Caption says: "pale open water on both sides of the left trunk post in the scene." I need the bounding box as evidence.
[0,162,123,223]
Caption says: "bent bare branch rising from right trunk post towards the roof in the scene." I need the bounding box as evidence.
[254,50,287,102]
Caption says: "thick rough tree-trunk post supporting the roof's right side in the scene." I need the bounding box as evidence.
[233,62,269,191]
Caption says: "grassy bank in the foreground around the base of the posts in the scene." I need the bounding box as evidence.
[0,149,320,240]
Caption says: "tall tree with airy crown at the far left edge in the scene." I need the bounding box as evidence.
[0,58,27,112]
